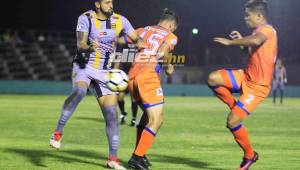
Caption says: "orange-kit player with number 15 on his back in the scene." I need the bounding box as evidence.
[124,9,178,169]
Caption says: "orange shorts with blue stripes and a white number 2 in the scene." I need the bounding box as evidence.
[218,69,270,119]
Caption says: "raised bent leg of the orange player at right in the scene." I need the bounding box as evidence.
[208,69,242,109]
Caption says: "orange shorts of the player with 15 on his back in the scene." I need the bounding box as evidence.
[128,74,164,108]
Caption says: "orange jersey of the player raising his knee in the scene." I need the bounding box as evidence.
[245,25,277,86]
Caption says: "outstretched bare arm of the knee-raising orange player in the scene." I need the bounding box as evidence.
[214,32,267,47]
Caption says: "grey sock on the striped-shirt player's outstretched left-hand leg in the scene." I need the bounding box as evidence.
[56,87,87,133]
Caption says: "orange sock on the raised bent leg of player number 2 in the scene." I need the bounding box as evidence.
[211,86,235,109]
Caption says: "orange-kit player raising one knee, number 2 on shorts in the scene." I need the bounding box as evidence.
[208,0,277,170]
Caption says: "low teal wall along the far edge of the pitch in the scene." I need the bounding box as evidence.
[0,81,300,97]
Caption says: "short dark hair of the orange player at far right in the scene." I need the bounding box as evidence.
[246,0,268,17]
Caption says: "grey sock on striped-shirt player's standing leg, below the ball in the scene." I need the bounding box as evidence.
[102,106,119,157]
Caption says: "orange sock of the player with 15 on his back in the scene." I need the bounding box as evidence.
[134,127,155,156]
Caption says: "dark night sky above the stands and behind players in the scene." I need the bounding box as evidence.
[1,0,300,59]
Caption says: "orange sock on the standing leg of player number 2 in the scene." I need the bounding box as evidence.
[231,124,254,159]
